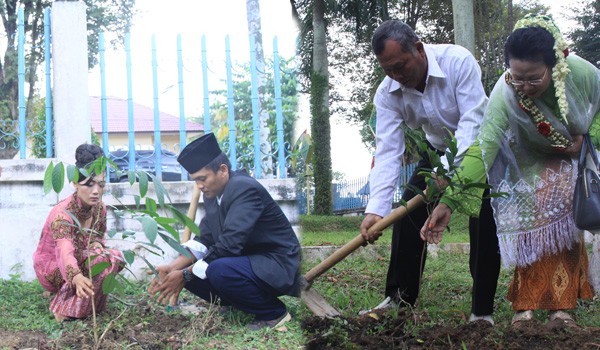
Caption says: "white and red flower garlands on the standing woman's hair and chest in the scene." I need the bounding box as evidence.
[506,14,572,151]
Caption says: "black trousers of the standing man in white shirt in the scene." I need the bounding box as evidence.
[385,155,500,316]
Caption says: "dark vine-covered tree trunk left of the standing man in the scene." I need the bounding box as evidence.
[310,0,333,215]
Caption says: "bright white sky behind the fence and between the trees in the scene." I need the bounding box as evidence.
[89,0,580,179]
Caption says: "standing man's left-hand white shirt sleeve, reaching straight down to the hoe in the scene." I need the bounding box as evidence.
[365,88,405,216]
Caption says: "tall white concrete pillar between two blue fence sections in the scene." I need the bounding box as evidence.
[52,1,91,164]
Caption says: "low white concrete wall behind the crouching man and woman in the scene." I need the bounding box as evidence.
[0,159,298,281]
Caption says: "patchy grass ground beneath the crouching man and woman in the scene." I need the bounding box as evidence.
[0,278,304,349]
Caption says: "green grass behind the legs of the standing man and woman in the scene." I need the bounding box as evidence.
[302,215,600,330]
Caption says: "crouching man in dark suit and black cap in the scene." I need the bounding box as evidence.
[148,133,300,330]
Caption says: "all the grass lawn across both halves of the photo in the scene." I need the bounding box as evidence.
[0,213,600,349]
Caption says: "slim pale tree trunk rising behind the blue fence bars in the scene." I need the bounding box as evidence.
[246,0,273,177]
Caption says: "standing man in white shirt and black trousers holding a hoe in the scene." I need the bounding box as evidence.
[361,20,500,324]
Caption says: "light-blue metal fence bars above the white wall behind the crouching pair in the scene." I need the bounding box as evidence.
[0,6,291,180]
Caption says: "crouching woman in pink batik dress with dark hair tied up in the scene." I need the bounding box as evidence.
[33,144,124,322]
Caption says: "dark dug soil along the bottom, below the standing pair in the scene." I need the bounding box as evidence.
[302,310,600,350]
